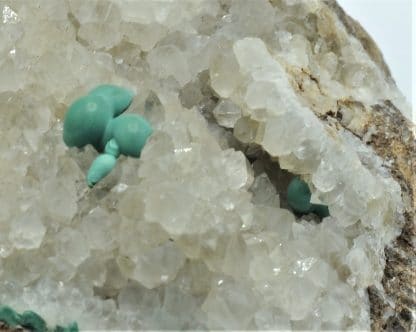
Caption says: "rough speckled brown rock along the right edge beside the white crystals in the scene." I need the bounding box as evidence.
[367,100,416,331]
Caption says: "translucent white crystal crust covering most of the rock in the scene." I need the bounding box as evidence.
[0,0,401,330]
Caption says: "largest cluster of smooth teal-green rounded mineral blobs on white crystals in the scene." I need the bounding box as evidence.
[63,84,153,187]
